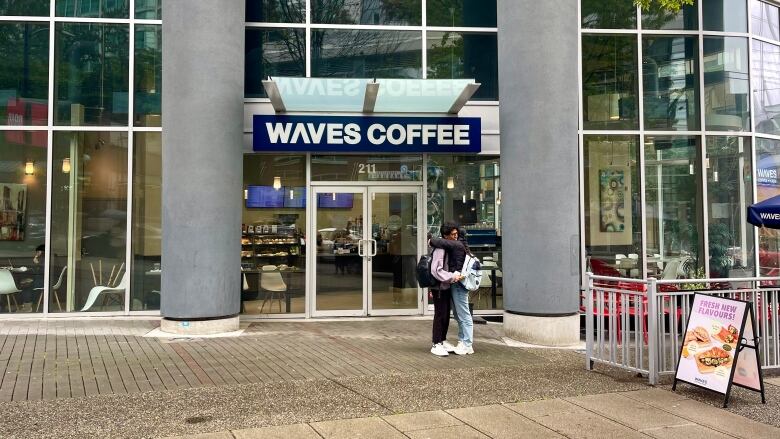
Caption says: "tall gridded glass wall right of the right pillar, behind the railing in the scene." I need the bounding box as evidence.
[580,0,768,279]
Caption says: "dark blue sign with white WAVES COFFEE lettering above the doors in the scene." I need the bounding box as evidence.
[252,115,482,153]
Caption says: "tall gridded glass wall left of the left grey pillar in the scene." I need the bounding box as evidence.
[0,0,162,313]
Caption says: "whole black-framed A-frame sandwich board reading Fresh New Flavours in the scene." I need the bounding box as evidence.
[672,294,766,407]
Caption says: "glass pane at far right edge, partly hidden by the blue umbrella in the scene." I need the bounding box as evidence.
[756,138,780,276]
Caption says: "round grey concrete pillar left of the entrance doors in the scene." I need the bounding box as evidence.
[161,0,245,333]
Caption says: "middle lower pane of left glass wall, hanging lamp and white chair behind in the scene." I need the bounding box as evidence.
[49,132,129,312]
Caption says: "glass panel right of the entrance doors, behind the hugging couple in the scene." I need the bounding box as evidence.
[426,154,504,309]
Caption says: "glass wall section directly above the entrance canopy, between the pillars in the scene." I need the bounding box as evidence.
[244,0,498,101]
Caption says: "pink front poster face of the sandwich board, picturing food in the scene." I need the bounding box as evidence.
[675,294,747,395]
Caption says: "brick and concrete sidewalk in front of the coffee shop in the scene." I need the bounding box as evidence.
[0,318,780,438]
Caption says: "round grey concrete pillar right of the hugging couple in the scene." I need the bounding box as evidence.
[498,0,579,346]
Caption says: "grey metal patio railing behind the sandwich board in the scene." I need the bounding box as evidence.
[581,273,780,384]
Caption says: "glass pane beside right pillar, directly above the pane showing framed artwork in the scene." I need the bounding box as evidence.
[582,35,639,130]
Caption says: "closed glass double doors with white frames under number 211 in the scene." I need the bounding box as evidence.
[310,186,422,316]
